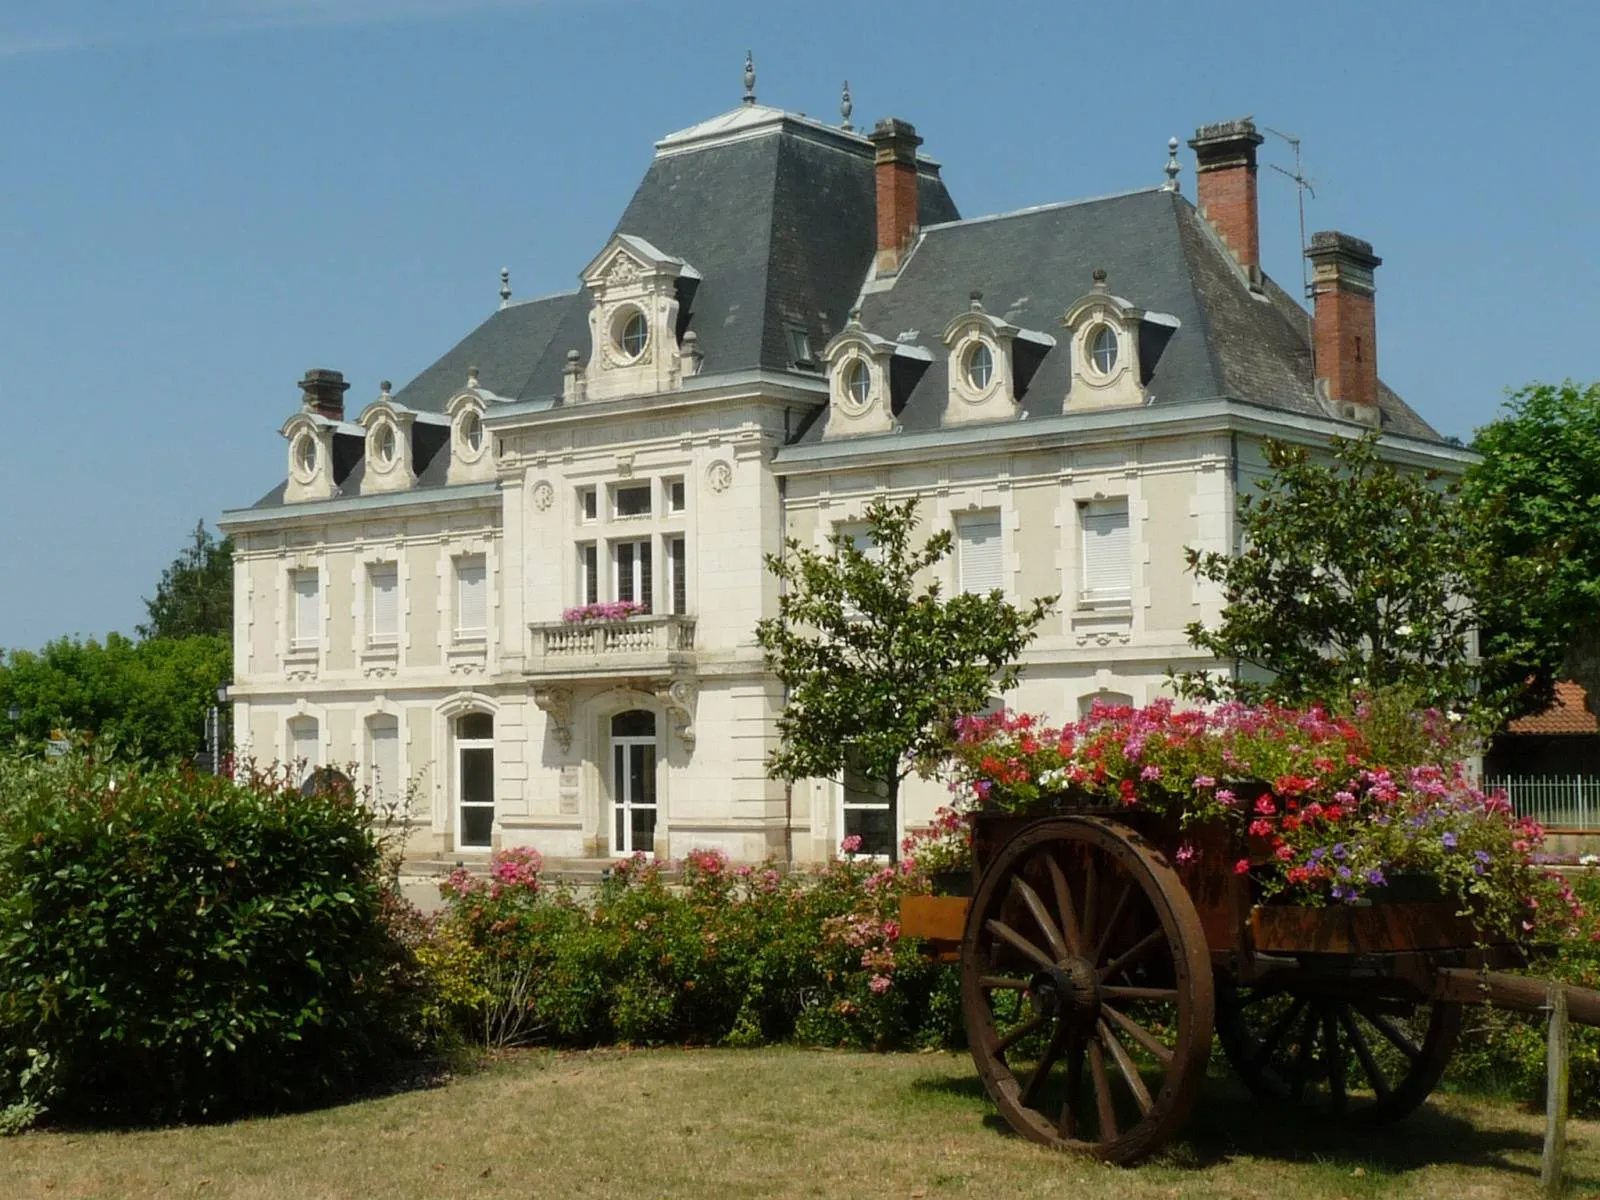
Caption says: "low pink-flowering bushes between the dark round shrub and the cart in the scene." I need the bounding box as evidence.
[421,851,960,1048]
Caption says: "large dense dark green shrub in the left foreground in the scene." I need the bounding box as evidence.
[0,754,408,1120]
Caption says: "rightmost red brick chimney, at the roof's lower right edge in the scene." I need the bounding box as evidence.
[1306,232,1382,421]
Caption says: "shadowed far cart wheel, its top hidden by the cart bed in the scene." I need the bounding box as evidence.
[1216,976,1461,1125]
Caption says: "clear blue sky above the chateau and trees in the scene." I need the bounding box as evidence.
[0,0,1600,646]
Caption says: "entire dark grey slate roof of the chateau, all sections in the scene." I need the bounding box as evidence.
[243,106,1438,507]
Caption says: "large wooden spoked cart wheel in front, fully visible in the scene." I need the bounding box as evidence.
[962,816,1213,1163]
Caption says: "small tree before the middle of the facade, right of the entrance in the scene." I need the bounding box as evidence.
[755,499,1056,857]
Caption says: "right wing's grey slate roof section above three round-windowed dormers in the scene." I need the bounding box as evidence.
[803,187,1438,442]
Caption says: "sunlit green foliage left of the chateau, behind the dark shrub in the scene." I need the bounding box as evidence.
[0,634,234,760]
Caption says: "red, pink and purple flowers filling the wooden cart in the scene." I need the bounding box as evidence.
[947,701,1579,938]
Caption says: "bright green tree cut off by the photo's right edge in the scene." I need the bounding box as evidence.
[1462,381,1600,707]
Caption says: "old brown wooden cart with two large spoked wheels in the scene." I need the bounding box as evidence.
[901,806,1600,1163]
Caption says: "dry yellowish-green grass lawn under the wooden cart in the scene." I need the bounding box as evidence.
[0,1048,1600,1200]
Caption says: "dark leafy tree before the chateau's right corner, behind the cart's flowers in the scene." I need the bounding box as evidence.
[1176,434,1494,709]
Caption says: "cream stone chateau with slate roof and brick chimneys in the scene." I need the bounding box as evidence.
[222,72,1466,861]
